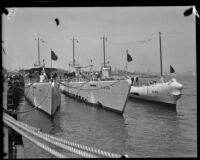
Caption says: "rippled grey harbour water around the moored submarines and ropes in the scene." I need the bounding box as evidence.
[19,75,197,158]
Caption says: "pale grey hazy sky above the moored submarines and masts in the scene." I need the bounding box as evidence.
[2,6,196,72]
